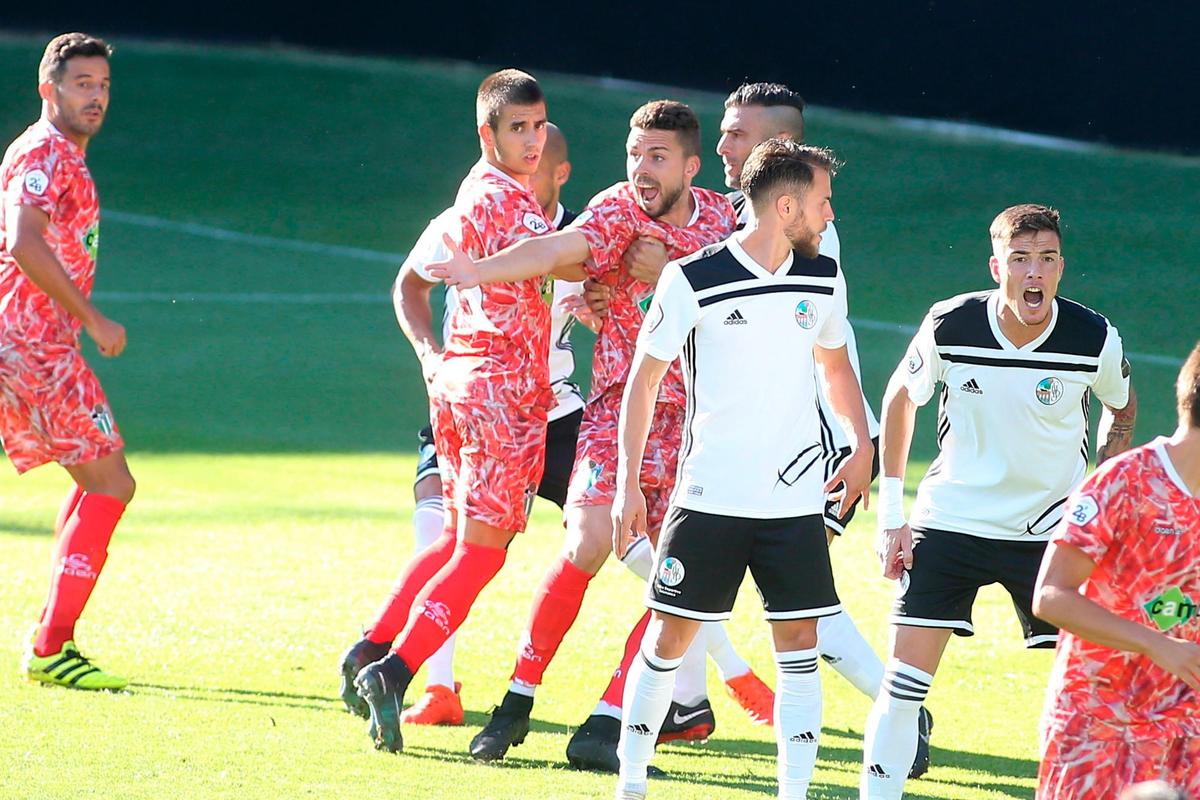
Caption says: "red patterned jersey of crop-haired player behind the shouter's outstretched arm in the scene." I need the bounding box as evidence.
[432,162,554,409]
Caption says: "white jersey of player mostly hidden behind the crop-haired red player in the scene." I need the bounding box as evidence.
[402,204,583,422]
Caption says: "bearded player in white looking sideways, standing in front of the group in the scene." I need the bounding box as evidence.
[612,139,872,799]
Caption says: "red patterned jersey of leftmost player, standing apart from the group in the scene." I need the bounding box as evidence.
[0,119,100,347]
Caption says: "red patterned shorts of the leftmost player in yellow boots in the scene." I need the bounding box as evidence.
[0,341,125,473]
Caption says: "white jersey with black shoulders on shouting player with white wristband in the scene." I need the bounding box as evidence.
[905,290,1129,541]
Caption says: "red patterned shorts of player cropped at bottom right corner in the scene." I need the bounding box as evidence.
[1037,734,1200,800]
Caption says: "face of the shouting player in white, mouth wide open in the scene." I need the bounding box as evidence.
[991,230,1066,327]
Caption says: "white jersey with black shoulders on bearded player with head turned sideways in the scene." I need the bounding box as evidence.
[637,232,846,519]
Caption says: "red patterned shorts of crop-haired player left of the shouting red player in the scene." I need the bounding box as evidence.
[430,391,546,531]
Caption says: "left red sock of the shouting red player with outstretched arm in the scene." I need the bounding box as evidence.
[512,555,592,686]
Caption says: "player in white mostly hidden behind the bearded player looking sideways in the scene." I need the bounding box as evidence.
[716,83,934,777]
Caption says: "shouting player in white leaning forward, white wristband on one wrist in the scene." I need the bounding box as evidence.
[860,205,1135,800]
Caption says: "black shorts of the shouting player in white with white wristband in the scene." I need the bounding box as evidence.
[889,529,1058,648]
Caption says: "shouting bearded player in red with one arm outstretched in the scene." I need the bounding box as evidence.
[430,101,769,770]
